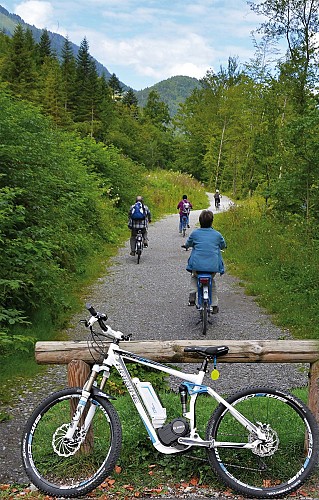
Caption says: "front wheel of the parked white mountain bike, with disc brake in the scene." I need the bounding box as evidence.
[22,388,122,497]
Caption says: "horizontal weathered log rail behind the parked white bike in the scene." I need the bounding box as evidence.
[35,339,319,364]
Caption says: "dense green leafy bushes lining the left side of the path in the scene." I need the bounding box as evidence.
[0,89,143,340]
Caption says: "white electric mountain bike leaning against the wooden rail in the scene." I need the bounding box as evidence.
[22,305,319,498]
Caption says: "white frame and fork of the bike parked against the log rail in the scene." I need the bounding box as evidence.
[65,318,266,454]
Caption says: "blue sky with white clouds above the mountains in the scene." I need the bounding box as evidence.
[0,0,262,90]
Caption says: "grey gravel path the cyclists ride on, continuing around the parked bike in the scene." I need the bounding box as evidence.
[0,195,307,492]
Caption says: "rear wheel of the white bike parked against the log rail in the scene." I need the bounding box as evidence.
[206,387,319,498]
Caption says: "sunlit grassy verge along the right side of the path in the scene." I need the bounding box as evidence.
[218,199,319,339]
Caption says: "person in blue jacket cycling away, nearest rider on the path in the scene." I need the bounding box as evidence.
[185,210,226,314]
